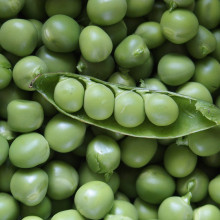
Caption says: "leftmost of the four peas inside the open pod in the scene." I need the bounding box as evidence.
[54,78,84,113]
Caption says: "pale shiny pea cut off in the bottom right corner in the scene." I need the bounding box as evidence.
[193,204,220,220]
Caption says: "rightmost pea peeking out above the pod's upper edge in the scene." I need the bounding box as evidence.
[176,82,213,103]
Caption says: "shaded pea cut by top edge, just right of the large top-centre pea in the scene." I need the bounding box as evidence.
[126,0,154,18]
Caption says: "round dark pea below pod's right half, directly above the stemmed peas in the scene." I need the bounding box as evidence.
[164,144,197,178]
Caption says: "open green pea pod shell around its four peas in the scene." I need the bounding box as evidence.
[31,73,220,139]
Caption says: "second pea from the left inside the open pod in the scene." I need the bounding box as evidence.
[83,83,115,120]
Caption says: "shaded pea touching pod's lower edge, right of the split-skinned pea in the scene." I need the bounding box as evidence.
[120,136,157,168]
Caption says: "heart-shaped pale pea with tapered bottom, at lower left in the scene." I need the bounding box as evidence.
[10,168,48,206]
